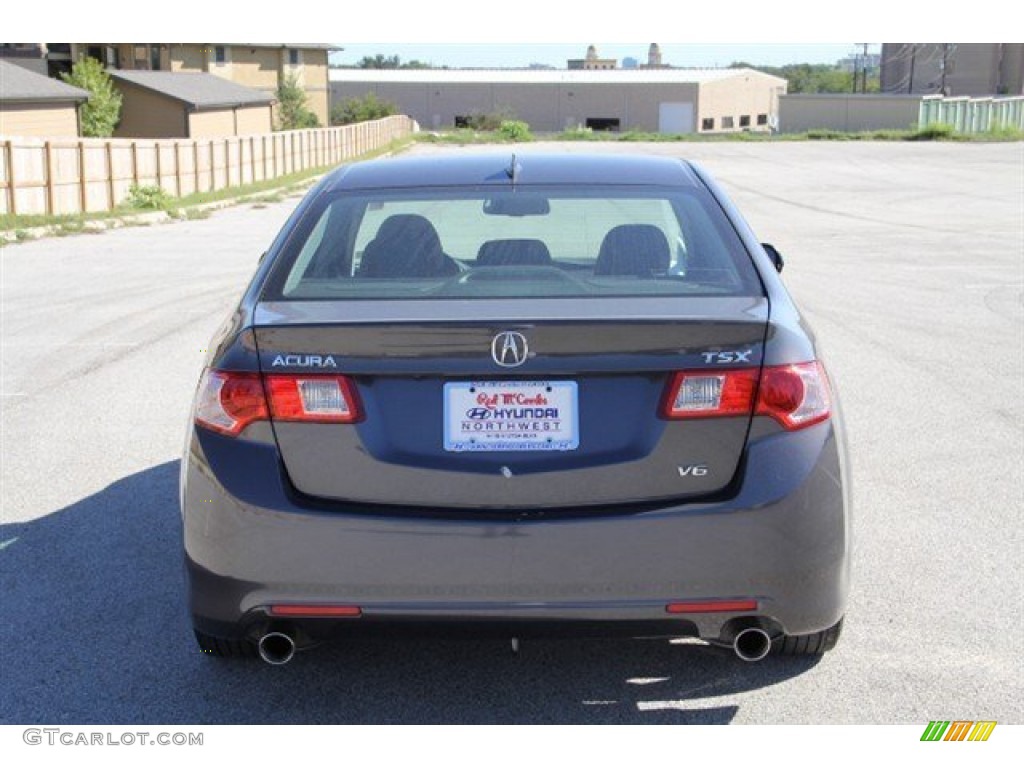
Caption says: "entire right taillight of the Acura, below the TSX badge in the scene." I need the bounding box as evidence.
[662,361,831,430]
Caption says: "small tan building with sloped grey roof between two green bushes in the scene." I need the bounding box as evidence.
[111,70,272,138]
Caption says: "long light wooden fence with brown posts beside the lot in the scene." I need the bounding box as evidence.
[0,116,416,219]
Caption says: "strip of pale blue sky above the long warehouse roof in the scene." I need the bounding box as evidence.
[331,42,860,69]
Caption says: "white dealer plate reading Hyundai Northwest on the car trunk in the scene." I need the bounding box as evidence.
[444,381,580,452]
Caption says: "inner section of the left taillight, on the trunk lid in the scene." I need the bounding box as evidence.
[264,374,361,424]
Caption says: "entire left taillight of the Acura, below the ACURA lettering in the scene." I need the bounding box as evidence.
[196,370,362,437]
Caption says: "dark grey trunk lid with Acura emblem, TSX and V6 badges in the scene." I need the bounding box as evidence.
[254,297,768,509]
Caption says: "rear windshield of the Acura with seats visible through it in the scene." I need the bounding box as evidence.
[263,186,761,301]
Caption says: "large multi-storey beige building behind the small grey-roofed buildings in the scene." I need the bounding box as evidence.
[58,43,339,126]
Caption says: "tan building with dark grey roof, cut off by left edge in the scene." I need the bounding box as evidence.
[0,58,89,138]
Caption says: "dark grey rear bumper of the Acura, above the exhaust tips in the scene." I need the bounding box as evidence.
[182,423,850,640]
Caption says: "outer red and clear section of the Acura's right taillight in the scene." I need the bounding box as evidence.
[757,360,831,429]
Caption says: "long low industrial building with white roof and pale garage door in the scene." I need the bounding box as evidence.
[330,69,786,133]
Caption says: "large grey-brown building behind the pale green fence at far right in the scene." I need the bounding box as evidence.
[882,43,1024,96]
